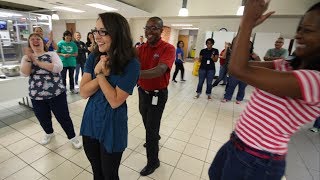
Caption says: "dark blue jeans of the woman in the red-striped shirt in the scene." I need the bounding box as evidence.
[209,140,286,180]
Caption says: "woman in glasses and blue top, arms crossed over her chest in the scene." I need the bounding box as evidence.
[80,13,140,180]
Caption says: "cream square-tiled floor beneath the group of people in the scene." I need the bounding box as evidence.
[0,63,320,180]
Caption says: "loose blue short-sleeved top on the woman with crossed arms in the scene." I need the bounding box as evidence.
[80,53,140,153]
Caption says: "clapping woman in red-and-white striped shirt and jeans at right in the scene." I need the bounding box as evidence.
[209,0,320,180]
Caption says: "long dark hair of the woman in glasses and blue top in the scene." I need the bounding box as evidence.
[94,12,136,74]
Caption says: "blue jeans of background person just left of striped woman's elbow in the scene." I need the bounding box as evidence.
[224,76,247,101]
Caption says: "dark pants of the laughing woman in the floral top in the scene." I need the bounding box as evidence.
[31,92,76,139]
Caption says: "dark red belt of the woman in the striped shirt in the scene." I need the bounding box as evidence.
[230,133,286,161]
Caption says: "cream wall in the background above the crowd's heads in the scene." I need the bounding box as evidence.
[53,17,300,56]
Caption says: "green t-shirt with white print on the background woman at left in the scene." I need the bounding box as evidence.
[57,40,78,67]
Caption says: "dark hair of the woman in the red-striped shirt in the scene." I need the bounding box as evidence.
[290,2,320,71]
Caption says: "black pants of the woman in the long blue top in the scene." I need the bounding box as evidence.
[82,136,123,180]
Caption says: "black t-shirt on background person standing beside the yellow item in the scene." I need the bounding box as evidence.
[200,48,219,70]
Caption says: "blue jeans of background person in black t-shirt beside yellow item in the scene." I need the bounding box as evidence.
[196,69,216,96]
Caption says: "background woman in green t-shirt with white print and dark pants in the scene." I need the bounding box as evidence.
[57,31,78,93]
